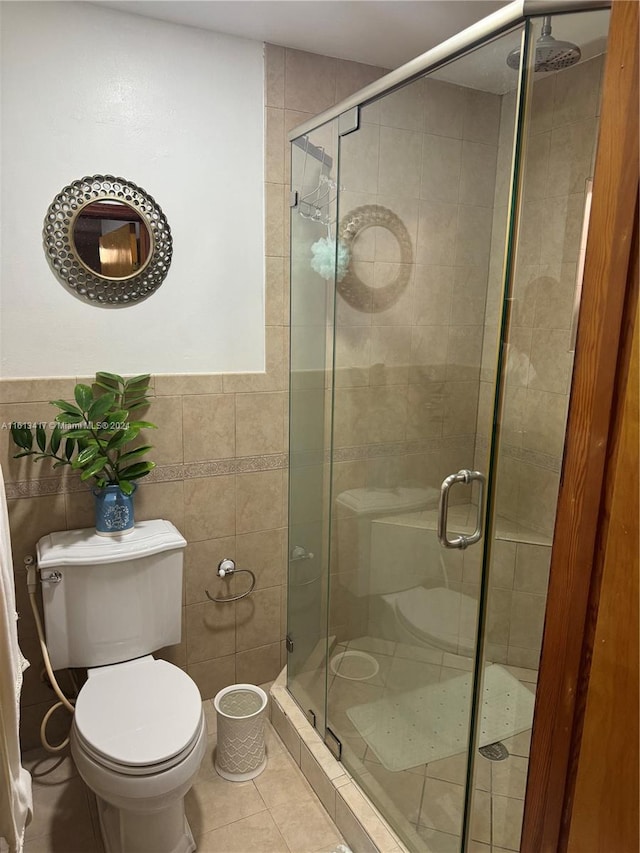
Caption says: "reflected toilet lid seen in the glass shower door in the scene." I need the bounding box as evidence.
[396,586,478,655]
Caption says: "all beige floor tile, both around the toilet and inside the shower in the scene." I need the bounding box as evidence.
[23,638,536,853]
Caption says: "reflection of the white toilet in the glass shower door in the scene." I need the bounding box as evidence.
[336,487,478,657]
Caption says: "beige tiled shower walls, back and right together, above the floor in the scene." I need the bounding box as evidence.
[312,57,603,668]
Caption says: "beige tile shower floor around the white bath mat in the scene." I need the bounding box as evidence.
[290,637,537,853]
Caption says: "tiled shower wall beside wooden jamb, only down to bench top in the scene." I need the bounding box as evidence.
[478,56,603,539]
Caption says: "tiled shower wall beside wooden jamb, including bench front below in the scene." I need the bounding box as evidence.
[478,56,604,669]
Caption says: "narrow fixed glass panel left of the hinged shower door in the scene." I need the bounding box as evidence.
[287,122,337,731]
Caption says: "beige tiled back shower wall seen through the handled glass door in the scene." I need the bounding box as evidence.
[330,78,504,639]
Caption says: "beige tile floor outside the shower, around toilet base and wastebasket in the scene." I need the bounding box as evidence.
[23,700,344,853]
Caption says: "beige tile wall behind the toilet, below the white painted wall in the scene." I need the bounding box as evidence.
[0,372,287,746]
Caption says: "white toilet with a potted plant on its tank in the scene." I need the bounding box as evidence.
[37,519,207,853]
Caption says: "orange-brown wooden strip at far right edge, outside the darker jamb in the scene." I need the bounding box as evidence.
[559,201,640,853]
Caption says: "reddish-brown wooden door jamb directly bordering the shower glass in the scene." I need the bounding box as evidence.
[521,0,638,853]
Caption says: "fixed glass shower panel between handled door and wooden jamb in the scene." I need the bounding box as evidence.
[470,11,609,850]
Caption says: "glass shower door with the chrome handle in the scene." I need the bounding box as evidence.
[327,23,521,853]
